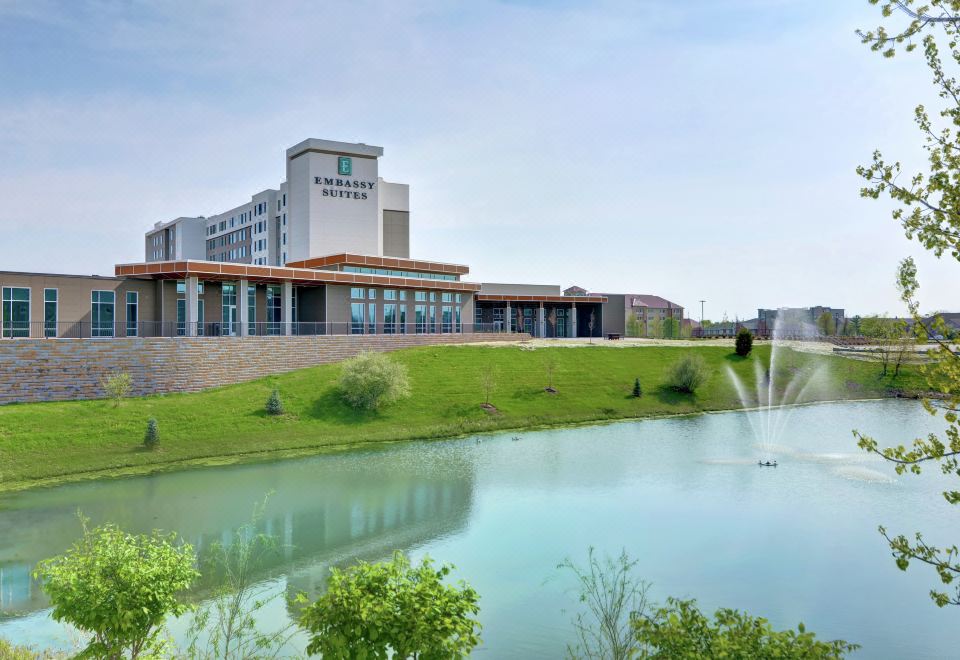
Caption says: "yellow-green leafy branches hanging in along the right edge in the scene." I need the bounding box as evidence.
[854,0,960,607]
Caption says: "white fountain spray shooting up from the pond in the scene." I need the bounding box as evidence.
[727,315,825,467]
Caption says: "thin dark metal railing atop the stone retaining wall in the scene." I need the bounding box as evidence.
[0,321,524,340]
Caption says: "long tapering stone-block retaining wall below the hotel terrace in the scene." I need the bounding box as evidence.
[0,333,529,404]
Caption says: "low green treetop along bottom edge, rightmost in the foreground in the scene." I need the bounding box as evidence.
[633,598,859,660]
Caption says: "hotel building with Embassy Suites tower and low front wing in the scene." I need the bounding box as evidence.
[0,139,682,339]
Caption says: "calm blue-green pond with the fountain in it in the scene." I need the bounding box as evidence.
[0,400,960,658]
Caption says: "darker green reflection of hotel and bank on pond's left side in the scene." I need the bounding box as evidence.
[0,445,474,618]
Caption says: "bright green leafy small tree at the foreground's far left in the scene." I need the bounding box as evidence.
[34,520,199,659]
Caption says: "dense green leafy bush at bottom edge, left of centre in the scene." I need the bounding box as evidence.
[301,552,480,659]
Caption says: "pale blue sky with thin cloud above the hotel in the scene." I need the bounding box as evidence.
[0,0,960,320]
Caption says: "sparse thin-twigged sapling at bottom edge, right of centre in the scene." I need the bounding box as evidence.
[557,548,649,660]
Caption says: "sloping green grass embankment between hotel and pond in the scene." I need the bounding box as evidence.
[0,346,922,491]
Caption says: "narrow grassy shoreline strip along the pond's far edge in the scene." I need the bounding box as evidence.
[0,392,908,496]
